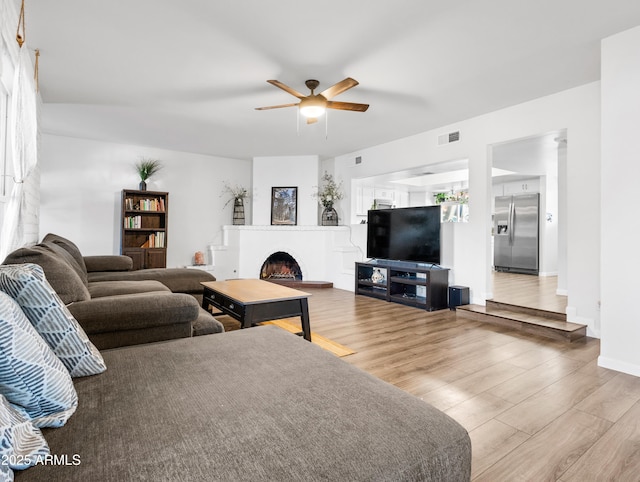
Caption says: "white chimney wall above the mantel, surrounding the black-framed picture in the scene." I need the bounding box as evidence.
[252,156,320,226]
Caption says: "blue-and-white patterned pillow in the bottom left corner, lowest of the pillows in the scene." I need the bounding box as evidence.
[0,395,49,472]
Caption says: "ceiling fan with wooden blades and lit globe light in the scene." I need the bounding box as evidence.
[256,77,369,124]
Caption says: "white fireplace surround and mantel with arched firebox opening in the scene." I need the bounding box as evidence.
[210,225,363,290]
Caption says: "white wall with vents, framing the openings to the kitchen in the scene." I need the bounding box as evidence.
[335,82,600,336]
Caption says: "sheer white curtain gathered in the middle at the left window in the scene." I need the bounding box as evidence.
[0,45,38,262]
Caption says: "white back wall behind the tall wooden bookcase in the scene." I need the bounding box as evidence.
[40,135,251,267]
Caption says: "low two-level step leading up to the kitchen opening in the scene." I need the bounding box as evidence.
[456,300,587,342]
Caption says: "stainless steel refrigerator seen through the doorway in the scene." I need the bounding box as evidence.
[493,193,540,274]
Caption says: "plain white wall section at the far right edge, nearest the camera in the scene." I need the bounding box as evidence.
[596,27,640,376]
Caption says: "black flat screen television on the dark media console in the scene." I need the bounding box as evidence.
[367,206,440,264]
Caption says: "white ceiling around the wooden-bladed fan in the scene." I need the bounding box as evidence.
[22,0,640,159]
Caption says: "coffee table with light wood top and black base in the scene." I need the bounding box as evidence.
[202,279,311,341]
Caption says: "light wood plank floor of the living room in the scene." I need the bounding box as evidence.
[232,277,640,482]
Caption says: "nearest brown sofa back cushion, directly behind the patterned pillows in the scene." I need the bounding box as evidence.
[3,245,91,305]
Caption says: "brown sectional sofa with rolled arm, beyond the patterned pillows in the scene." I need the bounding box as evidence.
[3,234,224,349]
